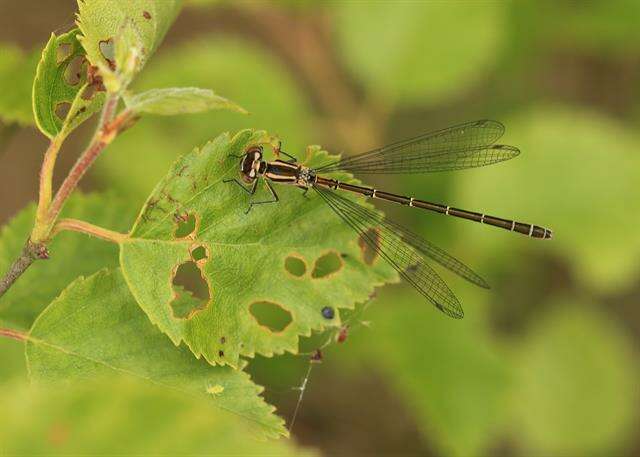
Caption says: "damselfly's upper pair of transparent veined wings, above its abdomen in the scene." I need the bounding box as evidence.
[316,120,520,174]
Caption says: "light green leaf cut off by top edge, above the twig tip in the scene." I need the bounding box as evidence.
[77,0,182,66]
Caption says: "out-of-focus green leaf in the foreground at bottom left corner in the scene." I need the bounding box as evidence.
[0,378,315,456]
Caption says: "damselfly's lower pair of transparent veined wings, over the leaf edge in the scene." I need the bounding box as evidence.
[314,187,488,318]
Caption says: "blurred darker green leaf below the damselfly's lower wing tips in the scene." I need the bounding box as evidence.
[332,284,512,456]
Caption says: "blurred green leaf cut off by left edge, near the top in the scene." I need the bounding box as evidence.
[0,43,40,126]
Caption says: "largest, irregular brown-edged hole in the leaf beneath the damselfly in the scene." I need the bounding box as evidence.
[171,261,211,319]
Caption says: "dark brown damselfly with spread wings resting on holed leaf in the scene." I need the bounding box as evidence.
[226,120,552,318]
